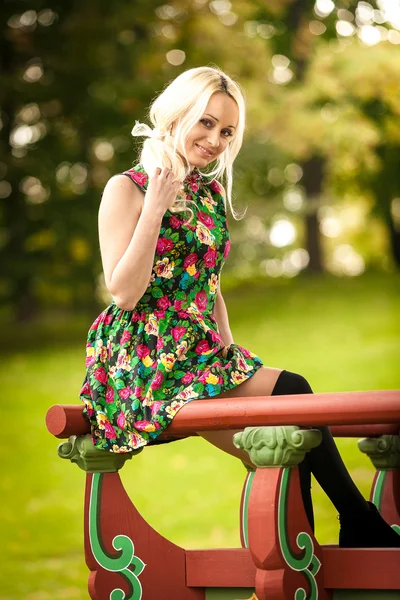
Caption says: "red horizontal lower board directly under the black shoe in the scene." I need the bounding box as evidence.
[322,546,400,597]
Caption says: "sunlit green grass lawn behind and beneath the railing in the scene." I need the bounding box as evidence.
[0,275,400,600]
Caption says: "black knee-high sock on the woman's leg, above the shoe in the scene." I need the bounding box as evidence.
[272,370,369,520]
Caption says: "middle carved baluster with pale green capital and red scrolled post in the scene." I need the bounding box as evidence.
[234,426,332,600]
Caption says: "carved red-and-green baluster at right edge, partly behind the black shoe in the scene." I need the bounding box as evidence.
[358,435,400,534]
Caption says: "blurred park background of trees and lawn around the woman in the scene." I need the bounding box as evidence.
[0,0,400,600]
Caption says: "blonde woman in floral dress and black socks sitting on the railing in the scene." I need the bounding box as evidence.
[81,67,400,546]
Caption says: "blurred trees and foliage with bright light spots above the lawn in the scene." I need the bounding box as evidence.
[0,0,400,319]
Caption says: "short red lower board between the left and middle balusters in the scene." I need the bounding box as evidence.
[186,548,256,588]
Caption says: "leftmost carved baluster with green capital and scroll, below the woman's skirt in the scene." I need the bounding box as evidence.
[58,435,205,600]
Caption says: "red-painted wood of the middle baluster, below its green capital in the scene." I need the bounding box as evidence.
[248,467,331,600]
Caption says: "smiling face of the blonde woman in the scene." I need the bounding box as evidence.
[174,92,239,169]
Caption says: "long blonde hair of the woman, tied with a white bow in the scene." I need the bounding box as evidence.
[132,67,246,219]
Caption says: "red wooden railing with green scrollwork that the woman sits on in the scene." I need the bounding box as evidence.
[46,390,400,600]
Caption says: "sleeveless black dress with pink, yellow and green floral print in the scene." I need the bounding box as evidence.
[80,163,263,452]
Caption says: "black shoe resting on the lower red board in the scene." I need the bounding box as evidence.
[339,502,400,548]
